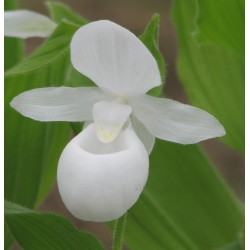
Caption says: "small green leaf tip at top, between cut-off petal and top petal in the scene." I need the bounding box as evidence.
[46,2,88,25]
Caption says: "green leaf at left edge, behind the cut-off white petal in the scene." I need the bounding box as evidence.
[4,0,23,71]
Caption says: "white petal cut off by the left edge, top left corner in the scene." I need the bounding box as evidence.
[4,10,57,38]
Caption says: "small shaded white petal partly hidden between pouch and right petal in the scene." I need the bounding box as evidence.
[131,115,155,155]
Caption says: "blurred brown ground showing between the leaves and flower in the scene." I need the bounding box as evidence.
[7,0,244,249]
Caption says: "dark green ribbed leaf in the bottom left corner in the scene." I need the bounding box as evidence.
[4,201,103,250]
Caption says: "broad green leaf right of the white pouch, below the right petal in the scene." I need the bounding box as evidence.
[125,140,244,250]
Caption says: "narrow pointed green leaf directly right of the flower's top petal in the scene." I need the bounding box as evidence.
[139,14,166,96]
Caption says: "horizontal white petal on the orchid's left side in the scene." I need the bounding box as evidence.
[10,87,108,122]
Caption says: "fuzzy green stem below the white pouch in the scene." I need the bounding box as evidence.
[112,213,127,250]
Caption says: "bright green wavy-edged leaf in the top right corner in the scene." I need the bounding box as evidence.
[195,0,245,57]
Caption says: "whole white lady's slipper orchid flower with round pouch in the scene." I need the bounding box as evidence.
[11,20,225,221]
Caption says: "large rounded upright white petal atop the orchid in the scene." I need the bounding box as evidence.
[70,20,161,95]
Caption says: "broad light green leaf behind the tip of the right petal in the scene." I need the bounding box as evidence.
[173,0,245,153]
